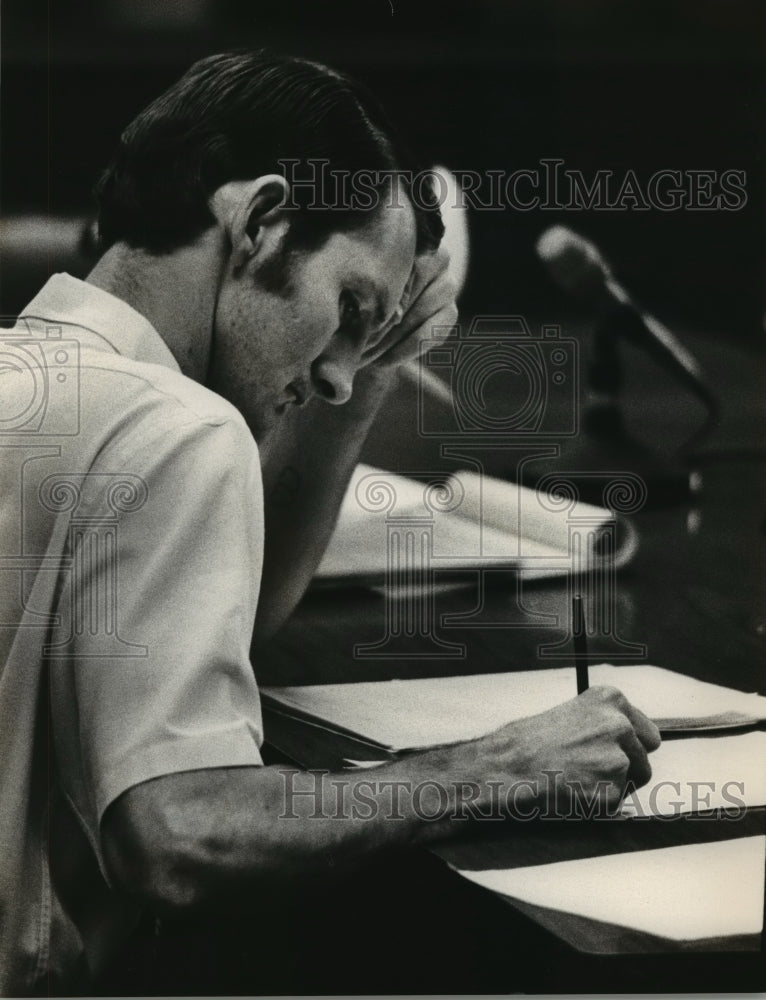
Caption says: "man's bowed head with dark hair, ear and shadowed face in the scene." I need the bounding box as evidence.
[96,52,443,436]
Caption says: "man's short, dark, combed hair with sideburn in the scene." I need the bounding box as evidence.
[95,51,444,253]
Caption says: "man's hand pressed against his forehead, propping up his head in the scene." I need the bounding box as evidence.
[361,249,457,368]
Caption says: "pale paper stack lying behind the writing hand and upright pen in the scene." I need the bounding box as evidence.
[263,664,766,750]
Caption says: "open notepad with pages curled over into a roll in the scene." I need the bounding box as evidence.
[315,465,638,585]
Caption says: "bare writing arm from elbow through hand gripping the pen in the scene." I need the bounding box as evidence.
[101,687,660,913]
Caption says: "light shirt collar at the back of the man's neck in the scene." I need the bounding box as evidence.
[19,274,180,371]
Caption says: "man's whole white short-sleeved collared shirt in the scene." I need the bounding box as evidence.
[0,274,263,995]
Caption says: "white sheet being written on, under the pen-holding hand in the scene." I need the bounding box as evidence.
[623,732,766,816]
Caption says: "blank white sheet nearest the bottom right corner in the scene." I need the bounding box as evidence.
[461,837,766,941]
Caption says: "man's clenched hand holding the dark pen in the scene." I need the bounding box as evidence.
[479,687,660,815]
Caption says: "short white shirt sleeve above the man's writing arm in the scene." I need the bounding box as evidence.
[50,408,263,846]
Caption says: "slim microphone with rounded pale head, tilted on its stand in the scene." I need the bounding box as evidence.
[536,226,719,449]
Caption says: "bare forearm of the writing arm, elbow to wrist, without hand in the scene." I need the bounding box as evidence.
[102,750,480,915]
